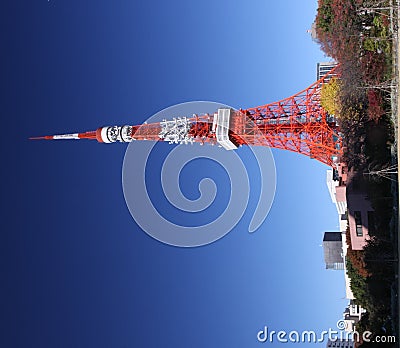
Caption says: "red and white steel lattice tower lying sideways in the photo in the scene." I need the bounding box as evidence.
[31,66,342,167]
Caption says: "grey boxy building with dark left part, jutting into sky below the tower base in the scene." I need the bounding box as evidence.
[322,232,344,270]
